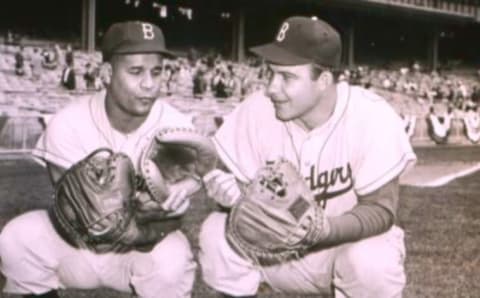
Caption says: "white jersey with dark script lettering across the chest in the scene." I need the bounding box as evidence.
[213,83,416,216]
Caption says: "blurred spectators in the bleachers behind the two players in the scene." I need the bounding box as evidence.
[0,44,480,135]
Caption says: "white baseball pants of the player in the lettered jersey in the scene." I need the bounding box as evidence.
[199,212,406,298]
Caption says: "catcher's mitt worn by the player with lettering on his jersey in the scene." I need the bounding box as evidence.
[226,160,328,266]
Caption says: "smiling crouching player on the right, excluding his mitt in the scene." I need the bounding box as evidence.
[199,17,416,297]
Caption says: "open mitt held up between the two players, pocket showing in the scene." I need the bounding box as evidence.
[136,128,217,222]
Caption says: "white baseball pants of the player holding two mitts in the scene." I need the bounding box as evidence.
[0,210,196,298]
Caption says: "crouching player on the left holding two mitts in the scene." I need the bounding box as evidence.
[0,22,215,298]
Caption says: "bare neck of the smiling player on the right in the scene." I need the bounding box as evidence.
[295,84,337,131]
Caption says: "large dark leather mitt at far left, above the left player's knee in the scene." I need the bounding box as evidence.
[49,148,137,253]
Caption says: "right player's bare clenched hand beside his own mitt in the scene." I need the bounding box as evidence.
[203,169,242,208]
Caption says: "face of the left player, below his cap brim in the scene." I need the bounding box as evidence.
[107,54,162,117]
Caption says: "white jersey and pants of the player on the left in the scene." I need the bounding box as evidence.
[0,92,196,298]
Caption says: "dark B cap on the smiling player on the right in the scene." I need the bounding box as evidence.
[250,16,342,68]
